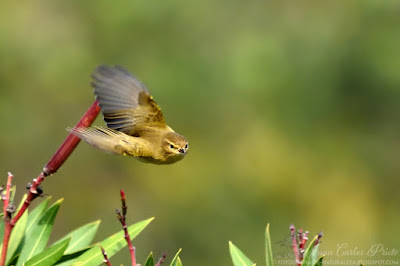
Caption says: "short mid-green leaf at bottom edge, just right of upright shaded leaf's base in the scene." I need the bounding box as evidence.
[25,239,70,266]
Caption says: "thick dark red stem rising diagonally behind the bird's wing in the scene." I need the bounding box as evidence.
[0,101,100,266]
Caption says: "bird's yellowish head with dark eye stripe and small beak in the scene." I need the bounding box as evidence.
[162,132,189,163]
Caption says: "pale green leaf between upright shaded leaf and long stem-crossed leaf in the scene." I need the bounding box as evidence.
[53,220,101,253]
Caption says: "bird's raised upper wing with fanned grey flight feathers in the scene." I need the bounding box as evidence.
[92,65,168,136]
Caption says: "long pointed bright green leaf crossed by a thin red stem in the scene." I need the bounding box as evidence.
[71,218,154,266]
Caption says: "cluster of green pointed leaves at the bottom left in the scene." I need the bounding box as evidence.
[0,194,182,266]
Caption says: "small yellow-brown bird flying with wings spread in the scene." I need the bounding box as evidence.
[67,65,189,164]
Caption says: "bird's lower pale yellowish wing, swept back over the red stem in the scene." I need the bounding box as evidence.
[67,127,152,157]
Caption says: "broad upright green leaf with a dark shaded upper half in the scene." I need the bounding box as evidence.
[17,199,64,266]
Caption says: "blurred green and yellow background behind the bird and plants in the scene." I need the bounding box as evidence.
[0,0,400,265]
